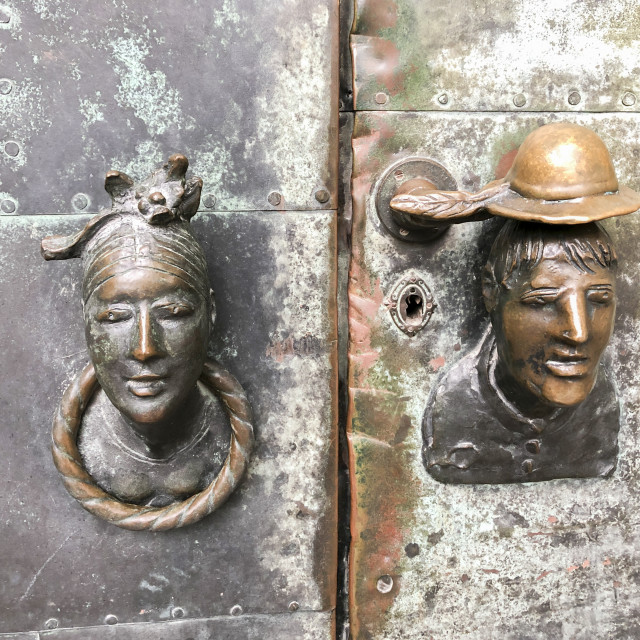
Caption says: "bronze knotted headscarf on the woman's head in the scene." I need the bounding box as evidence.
[42,154,209,302]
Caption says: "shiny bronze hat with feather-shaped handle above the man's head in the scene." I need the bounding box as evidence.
[391,122,640,224]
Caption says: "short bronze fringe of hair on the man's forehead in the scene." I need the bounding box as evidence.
[483,220,618,287]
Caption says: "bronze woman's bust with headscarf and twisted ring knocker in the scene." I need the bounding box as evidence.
[42,155,254,531]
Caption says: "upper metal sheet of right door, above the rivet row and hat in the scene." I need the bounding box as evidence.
[351,0,640,111]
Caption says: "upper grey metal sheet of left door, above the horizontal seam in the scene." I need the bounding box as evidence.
[0,0,338,214]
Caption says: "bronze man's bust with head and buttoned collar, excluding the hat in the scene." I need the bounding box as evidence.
[423,221,620,483]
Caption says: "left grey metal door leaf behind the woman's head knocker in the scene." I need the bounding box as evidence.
[0,0,338,640]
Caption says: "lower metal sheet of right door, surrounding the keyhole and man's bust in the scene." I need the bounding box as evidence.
[349,112,640,640]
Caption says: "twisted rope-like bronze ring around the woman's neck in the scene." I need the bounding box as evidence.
[51,360,254,531]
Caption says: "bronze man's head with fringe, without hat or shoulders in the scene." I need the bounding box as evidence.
[483,220,617,417]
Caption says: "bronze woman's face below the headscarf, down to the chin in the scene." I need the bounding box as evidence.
[84,267,210,426]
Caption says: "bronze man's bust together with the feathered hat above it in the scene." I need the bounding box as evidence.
[391,123,640,483]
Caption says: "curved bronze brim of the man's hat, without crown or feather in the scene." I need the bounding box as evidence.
[485,186,640,224]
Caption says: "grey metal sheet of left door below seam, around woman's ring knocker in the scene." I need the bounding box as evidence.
[0,211,337,640]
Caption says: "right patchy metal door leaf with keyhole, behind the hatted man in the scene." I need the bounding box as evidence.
[347,0,640,640]
